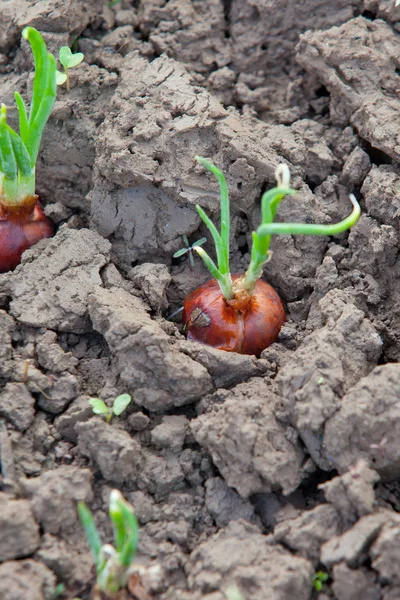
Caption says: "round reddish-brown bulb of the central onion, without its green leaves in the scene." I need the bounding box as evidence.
[182,275,286,356]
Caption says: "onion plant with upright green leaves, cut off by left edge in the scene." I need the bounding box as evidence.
[0,27,83,273]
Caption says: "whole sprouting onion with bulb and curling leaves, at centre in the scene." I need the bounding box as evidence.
[182,156,361,356]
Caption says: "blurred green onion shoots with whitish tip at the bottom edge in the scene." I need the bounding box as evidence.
[78,490,139,596]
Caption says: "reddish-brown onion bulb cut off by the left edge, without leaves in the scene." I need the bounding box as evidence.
[0,196,54,273]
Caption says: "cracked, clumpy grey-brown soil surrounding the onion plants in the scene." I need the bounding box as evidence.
[0,0,400,600]
